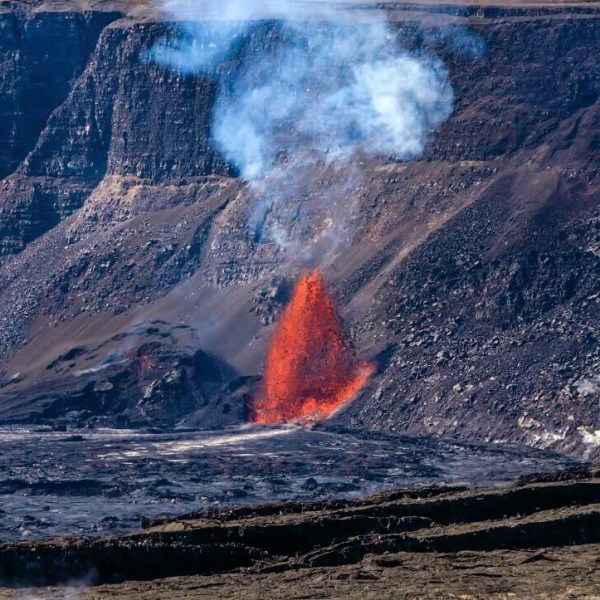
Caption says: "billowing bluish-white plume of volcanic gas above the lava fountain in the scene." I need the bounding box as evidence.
[150,0,453,246]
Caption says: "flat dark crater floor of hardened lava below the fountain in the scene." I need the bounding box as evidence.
[0,426,580,541]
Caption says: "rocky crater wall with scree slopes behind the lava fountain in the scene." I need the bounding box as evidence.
[0,2,600,455]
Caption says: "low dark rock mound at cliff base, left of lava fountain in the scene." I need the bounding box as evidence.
[2,342,247,428]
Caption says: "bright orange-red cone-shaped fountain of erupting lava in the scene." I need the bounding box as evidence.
[252,270,374,423]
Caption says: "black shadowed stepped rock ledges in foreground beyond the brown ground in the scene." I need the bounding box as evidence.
[0,472,600,585]
